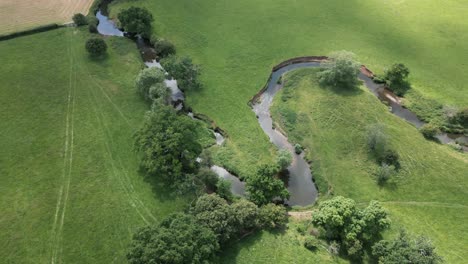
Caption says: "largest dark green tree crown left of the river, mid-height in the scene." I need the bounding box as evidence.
[135,104,201,188]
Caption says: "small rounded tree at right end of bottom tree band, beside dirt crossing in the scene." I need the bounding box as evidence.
[259,203,288,229]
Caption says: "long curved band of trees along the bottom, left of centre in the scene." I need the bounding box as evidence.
[127,194,287,264]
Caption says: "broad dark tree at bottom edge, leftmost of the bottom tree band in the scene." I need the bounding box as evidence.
[127,213,219,264]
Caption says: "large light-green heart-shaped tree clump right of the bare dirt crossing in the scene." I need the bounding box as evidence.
[312,196,390,259]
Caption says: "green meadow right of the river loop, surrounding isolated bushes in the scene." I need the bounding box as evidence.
[272,69,468,263]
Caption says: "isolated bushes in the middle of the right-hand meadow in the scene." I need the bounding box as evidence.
[367,124,400,185]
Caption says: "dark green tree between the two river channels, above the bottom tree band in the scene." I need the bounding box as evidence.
[245,165,289,205]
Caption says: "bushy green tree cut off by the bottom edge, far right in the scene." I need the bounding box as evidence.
[372,230,444,264]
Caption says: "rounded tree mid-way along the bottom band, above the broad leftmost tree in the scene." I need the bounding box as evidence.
[191,194,237,243]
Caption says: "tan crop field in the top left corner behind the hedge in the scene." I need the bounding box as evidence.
[0,0,93,34]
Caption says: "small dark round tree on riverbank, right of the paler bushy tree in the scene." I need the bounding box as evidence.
[384,63,411,96]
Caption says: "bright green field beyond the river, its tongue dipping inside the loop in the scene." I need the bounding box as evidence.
[112,0,468,175]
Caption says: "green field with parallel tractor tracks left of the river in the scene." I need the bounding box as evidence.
[0,29,186,263]
